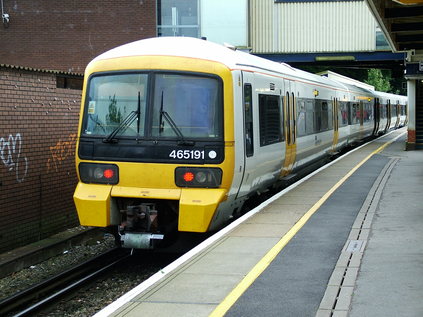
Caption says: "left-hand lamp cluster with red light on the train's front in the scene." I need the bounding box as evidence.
[79,163,119,185]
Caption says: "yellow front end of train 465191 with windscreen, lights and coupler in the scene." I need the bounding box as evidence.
[74,39,234,248]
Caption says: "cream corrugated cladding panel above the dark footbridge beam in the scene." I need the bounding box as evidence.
[250,0,377,53]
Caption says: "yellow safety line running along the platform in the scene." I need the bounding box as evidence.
[209,132,405,317]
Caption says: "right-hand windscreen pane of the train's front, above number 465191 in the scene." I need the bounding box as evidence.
[152,74,221,138]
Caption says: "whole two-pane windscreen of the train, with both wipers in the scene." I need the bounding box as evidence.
[82,72,223,140]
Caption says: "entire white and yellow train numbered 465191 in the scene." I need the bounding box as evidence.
[74,37,407,249]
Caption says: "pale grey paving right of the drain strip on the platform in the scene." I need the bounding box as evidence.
[350,144,423,317]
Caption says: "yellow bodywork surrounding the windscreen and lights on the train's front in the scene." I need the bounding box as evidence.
[74,56,234,232]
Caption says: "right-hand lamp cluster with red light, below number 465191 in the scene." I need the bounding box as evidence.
[175,167,223,188]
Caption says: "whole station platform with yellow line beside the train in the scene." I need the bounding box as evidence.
[95,128,423,317]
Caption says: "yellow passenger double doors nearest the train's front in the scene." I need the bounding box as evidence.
[281,80,297,177]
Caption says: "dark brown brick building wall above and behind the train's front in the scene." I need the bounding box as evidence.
[0,0,156,73]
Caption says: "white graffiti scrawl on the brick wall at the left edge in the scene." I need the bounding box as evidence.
[0,133,28,183]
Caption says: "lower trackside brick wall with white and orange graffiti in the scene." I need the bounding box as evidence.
[0,66,82,252]
